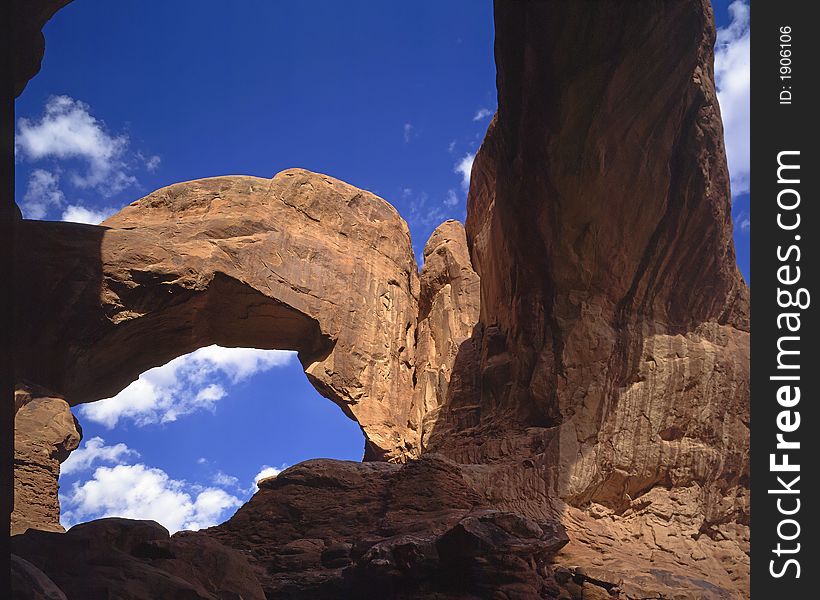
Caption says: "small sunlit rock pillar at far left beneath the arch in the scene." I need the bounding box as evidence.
[11,388,82,535]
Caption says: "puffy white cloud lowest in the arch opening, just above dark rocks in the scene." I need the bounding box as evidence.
[60,464,242,533]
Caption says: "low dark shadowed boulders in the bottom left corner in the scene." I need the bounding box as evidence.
[12,518,265,600]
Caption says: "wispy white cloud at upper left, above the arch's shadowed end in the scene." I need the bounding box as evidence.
[15,96,136,196]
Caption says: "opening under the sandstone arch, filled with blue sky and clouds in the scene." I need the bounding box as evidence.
[54,345,364,533]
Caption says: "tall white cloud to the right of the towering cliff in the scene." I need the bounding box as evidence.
[715,0,751,196]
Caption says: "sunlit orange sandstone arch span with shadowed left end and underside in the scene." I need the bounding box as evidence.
[16,169,419,459]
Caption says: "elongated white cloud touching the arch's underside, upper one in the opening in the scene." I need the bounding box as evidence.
[80,346,295,429]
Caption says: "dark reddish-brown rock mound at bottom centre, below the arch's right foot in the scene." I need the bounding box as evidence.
[201,454,567,600]
